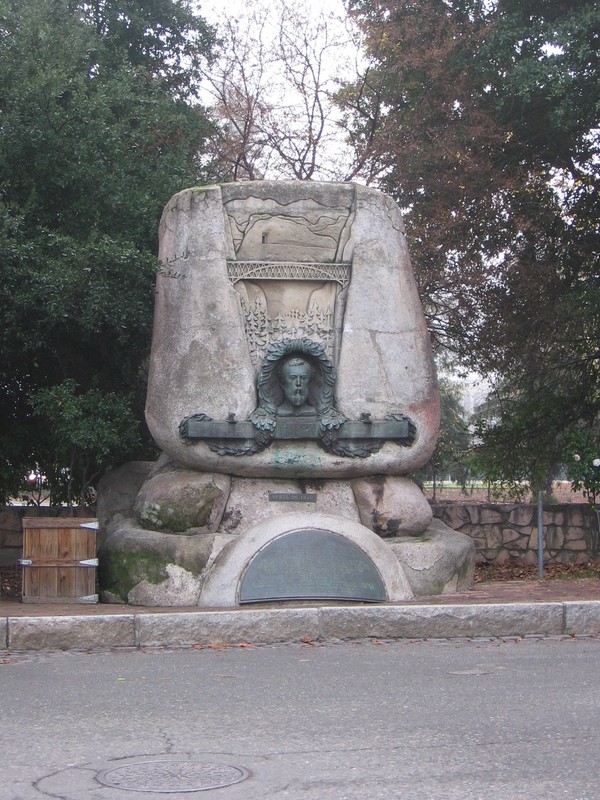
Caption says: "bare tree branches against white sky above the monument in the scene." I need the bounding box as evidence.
[205,0,358,180]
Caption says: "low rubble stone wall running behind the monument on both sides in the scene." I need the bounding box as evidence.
[0,503,599,566]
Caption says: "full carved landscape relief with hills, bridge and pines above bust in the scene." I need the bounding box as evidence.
[226,205,352,369]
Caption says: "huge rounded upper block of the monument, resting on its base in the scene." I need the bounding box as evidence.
[146,181,439,477]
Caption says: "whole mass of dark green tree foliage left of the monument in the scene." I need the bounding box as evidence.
[0,0,213,500]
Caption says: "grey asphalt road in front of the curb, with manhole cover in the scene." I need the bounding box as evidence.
[0,638,600,800]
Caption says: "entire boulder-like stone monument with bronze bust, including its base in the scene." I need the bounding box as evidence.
[98,181,474,607]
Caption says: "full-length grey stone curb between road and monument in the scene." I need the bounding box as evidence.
[0,600,600,651]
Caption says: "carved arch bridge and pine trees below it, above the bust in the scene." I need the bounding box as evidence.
[227,261,351,368]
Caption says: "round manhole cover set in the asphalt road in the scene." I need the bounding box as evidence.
[96,761,250,792]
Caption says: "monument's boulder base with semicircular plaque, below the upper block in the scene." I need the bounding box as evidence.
[98,460,474,607]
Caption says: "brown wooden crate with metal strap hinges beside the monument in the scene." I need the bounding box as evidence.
[20,517,98,603]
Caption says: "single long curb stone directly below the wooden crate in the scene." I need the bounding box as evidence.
[8,614,135,650]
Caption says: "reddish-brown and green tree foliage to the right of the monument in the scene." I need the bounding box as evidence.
[340,0,600,487]
